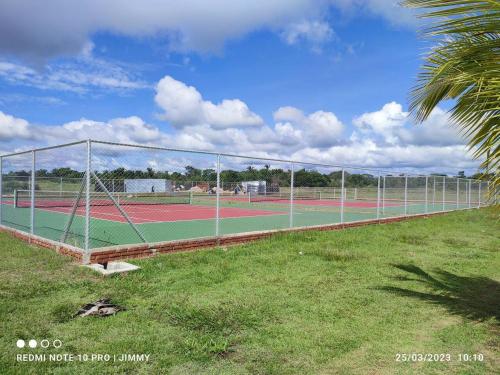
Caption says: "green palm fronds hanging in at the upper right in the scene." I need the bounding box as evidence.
[403,0,500,191]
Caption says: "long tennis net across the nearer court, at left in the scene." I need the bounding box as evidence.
[14,190,192,208]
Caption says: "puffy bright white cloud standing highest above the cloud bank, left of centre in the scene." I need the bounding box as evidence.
[155,76,263,128]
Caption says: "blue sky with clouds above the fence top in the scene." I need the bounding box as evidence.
[0,0,479,175]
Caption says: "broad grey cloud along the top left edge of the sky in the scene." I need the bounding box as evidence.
[0,0,334,58]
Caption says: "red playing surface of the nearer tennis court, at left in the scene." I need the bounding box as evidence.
[44,204,288,224]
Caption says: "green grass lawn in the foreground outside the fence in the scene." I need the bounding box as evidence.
[0,208,500,374]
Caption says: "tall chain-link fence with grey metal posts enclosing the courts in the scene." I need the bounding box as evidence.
[0,141,496,262]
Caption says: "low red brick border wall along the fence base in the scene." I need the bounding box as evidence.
[0,208,474,263]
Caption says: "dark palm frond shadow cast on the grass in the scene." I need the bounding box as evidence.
[380,264,500,324]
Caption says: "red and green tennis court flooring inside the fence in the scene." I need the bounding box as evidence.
[3,192,468,248]
